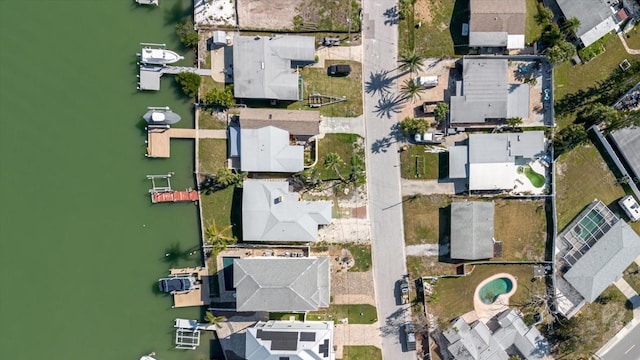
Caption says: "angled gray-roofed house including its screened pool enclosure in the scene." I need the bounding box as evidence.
[554,199,640,318]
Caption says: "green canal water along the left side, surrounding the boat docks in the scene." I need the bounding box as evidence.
[0,0,215,360]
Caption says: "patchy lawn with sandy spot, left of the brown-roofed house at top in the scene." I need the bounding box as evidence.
[398,0,460,58]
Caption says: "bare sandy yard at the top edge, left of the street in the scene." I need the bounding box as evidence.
[237,0,304,29]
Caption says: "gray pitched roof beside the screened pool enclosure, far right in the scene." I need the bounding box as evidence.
[564,221,640,302]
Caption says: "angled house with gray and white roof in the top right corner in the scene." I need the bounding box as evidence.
[556,0,616,47]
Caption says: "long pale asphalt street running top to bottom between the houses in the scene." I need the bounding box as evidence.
[362,0,416,360]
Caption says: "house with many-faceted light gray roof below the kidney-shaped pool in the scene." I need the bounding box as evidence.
[443,309,551,360]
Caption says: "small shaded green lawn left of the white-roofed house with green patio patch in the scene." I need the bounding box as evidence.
[400,145,449,180]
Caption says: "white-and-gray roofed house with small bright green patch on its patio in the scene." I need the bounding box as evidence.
[449,131,551,195]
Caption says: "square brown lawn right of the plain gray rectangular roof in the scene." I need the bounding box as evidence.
[493,199,547,261]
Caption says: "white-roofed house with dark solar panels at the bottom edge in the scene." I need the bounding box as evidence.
[244,320,335,360]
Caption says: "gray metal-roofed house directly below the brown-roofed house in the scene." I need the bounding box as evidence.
[450,57,530,125]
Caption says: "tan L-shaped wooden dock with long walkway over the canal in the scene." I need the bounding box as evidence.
[146,126,227,158]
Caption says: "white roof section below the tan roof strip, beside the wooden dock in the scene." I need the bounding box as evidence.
[240,126,304,173]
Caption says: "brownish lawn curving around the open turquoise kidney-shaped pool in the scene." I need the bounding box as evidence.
[429,265,545,324]
